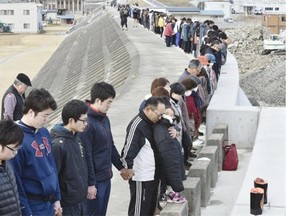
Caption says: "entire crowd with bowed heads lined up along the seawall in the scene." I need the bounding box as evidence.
[0,5,231,216]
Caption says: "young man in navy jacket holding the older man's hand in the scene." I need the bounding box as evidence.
[79,82,133,216]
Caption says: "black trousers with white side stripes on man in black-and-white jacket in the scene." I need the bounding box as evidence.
[128,179,159,216]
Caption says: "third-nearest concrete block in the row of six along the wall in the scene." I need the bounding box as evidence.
[188,160,211,207]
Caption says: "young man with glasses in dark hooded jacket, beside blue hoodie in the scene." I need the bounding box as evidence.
[51,100,88,216]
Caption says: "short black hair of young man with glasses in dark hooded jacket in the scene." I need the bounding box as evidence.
[61,99,88,125]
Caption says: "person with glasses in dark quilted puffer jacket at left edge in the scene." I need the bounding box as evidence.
[0,120,23,216]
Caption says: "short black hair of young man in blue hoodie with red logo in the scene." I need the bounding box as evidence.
[23,88,57,115]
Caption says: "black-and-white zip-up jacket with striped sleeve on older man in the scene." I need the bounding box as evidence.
[121,112,158,181]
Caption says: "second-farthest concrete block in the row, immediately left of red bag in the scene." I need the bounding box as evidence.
[206,133,224,172]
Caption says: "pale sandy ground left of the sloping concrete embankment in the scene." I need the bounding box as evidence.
[0,26,71,111]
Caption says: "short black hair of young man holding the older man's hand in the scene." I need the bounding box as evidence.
[90,82,116,103]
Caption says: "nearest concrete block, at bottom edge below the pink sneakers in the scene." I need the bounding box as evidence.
[160,201,188,216]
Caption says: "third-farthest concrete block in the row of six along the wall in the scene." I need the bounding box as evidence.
[198,146,219,188]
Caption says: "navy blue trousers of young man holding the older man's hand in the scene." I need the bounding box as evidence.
[86,179,111,216]
